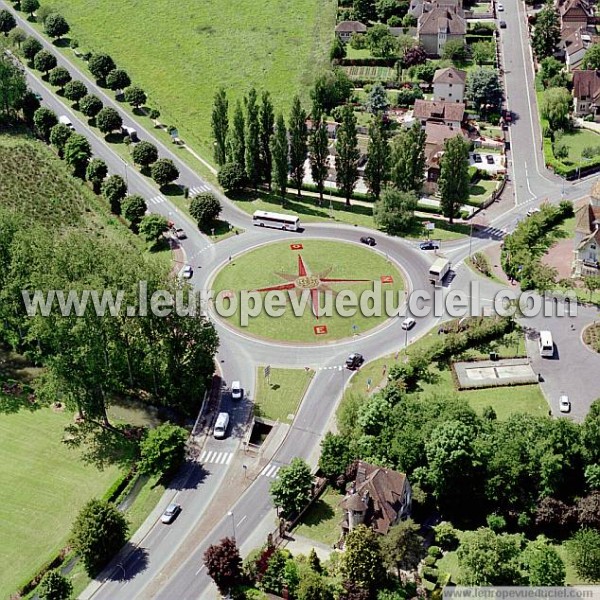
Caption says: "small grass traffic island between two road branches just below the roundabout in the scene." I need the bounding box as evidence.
[254,366,315,423]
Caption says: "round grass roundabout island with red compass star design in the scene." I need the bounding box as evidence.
[212,239,404,343]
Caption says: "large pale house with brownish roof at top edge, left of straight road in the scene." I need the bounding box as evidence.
[417,1,467,56]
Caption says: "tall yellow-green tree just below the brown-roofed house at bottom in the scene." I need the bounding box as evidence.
[342,525,385,590]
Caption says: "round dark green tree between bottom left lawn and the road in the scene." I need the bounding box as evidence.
[71,500,129,577]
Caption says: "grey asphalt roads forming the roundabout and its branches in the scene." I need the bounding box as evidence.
[0,0,590,600]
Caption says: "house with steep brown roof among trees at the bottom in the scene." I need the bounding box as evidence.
[340,460,412,535]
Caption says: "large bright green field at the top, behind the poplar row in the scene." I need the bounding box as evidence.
[52,0,336,160]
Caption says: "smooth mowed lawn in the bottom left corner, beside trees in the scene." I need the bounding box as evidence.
[0,408,118,598]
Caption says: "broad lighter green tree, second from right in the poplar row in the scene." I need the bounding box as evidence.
[391,121,425,194]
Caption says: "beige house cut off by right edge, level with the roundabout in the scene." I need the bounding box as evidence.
[572,181,600,277]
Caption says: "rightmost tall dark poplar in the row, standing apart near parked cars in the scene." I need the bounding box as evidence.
[438,135,470,223]
